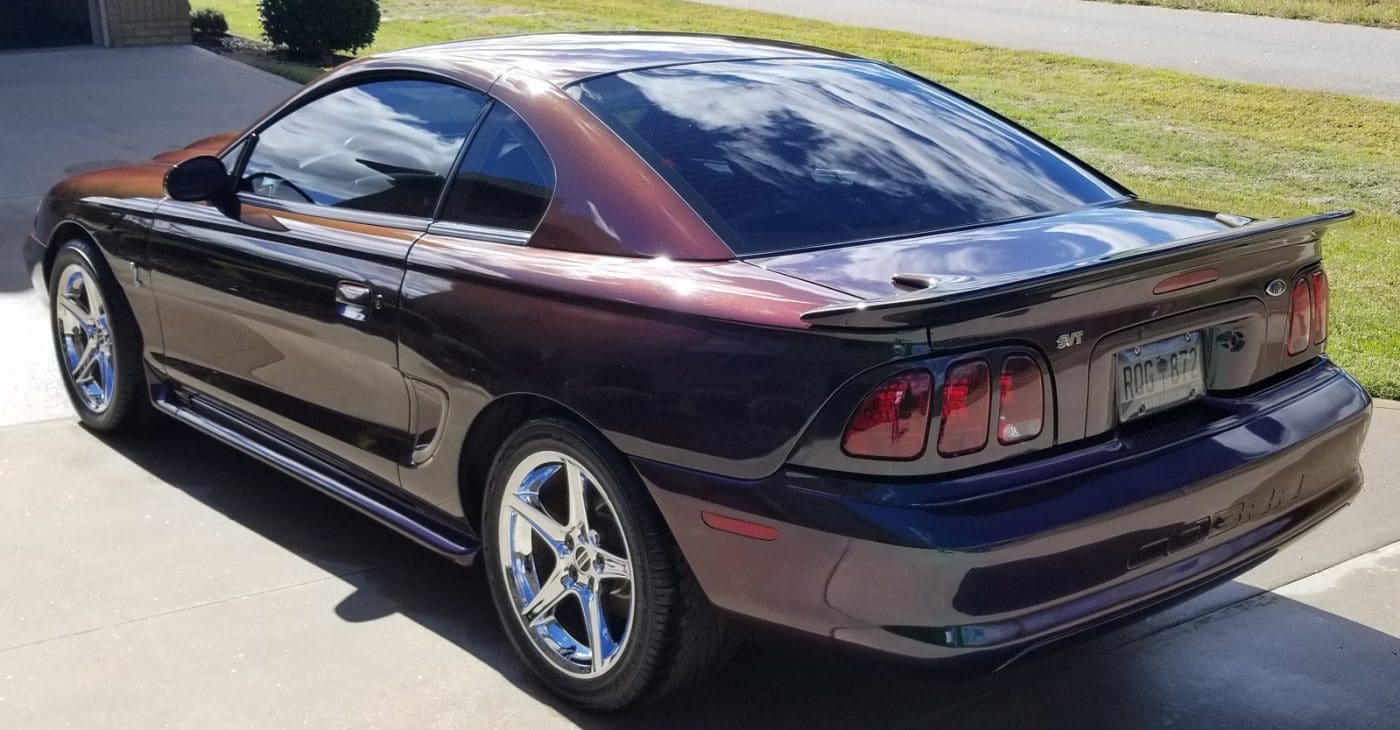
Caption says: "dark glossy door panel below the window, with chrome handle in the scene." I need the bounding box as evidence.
[151,202,420,483]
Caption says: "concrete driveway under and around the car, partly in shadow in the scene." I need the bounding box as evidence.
[0,42,1400,729]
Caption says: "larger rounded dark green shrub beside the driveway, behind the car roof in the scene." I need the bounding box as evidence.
[258,0,379,60]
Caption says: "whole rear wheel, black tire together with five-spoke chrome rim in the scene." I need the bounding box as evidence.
[482,418,736,710]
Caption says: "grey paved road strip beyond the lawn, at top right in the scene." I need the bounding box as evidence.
[701,0,1400,101]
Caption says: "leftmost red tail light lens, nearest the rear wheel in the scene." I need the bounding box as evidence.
[841,369,934,460]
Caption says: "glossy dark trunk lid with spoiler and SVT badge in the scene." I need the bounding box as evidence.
[749,200,1351,443]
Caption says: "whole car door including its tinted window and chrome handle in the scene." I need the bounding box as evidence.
[150,77,486,483]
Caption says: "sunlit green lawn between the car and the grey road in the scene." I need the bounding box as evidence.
[196,0,1400,398]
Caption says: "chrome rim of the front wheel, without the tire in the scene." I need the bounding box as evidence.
[53,263,116,413]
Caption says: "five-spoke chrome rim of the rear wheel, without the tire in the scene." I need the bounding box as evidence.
[496,451,636,678]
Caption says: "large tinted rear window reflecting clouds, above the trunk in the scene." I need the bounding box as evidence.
[571,60,1121,256]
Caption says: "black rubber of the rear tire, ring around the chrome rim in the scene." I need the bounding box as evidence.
[482,419,669,710]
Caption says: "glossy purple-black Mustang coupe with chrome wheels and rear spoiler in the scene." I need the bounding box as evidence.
[25,32,1371,710]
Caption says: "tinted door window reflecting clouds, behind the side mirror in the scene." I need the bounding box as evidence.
[238,80,486,217]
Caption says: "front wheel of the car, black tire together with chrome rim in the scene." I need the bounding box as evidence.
[49,238,147,433]
